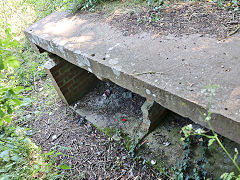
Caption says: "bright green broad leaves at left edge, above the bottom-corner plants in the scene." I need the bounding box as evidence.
[0,26,24,126]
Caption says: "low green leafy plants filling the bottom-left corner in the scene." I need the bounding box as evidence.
[0,126,56,179]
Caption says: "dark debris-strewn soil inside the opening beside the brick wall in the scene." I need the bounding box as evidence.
[76,81,146,121]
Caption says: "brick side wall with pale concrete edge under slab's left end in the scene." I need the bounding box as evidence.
[44,55,99,105]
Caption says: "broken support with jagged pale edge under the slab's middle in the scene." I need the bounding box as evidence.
[141,100,169,132]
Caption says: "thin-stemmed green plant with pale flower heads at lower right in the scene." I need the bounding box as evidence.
[182,85,240,180]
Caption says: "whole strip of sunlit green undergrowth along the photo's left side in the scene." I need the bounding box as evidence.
[0,0,70,179]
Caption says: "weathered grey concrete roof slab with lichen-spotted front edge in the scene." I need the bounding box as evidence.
[25,12,240,143]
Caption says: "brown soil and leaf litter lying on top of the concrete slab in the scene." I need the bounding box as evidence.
[107,2,240,39]
